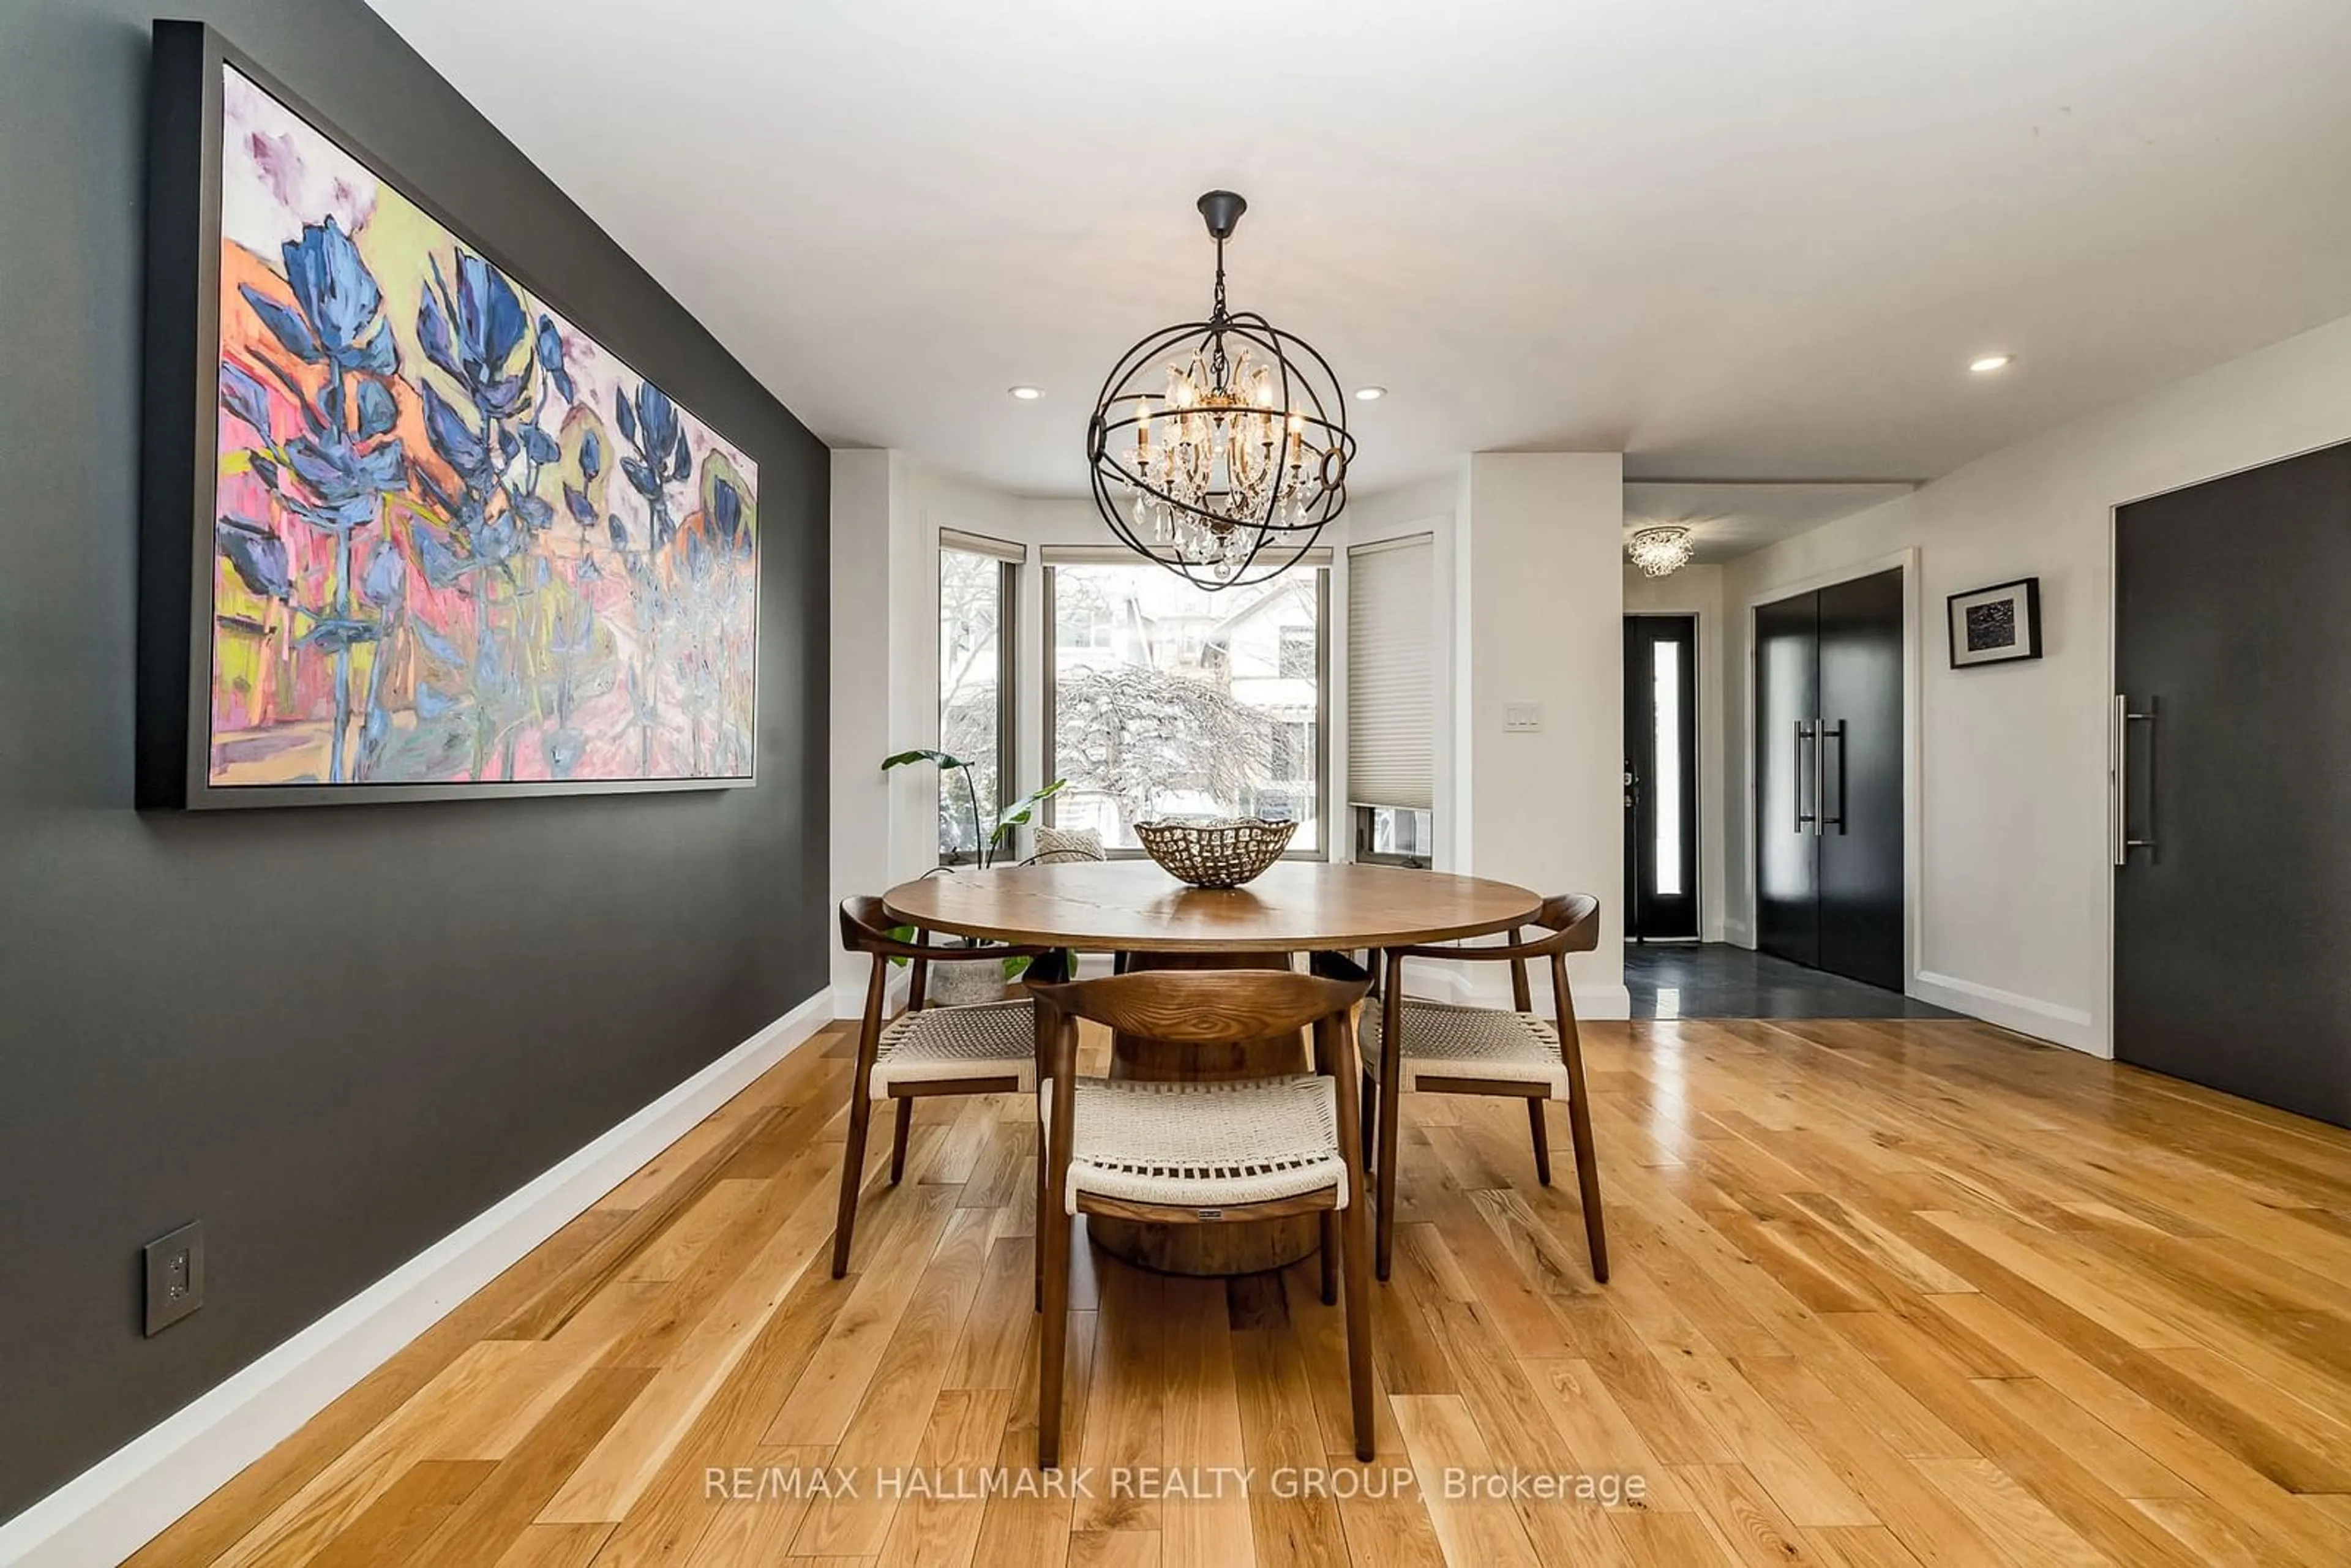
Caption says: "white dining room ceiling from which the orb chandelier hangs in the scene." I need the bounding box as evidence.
[374,0,2351,493]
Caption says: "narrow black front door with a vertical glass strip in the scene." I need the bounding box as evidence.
[1624,616,1697,940]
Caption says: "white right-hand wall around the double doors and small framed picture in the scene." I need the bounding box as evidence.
[1723,306,2351,1056]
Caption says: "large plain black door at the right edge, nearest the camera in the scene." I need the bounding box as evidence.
[2109,447,2351,1126]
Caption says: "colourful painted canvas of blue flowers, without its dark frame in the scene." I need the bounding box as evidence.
[209,68,759,787]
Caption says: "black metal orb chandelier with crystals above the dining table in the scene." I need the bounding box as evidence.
[1086,190,1354,593]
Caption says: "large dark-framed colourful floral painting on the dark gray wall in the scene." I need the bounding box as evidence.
[139,21,759,809]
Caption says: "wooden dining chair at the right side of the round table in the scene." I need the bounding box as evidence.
[1354,893,1608,1283]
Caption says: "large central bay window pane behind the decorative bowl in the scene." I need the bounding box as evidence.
[1046,562,1324,851]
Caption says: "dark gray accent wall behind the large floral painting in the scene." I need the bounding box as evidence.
[0,0,828,1518]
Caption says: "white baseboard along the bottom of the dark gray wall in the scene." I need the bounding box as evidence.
[0,992,832,1568]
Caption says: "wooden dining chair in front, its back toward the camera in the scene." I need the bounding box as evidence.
[1035,964,1373,1469]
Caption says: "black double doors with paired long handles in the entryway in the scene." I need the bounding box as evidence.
[1754,569,1904,989]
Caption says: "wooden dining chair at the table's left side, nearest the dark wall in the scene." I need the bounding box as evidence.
[832,896,1058,1279]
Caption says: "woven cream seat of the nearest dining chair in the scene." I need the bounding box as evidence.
[1044,1075,1347,1213]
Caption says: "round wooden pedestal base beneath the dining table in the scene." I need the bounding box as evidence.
[1086,952,1321,1277]
